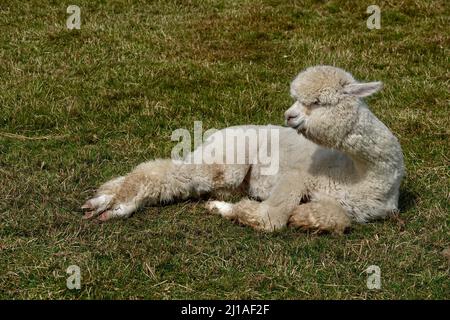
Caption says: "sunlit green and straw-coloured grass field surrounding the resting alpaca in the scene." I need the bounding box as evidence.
[0,0,450,299]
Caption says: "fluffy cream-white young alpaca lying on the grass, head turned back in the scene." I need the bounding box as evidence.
[82,66,404,234]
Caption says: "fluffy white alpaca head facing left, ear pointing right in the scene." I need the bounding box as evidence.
[285,66,382,144]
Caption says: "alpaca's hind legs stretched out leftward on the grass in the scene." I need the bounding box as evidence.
[82,159,249,221]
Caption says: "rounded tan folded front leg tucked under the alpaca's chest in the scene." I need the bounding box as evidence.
[288,199,351,234]
